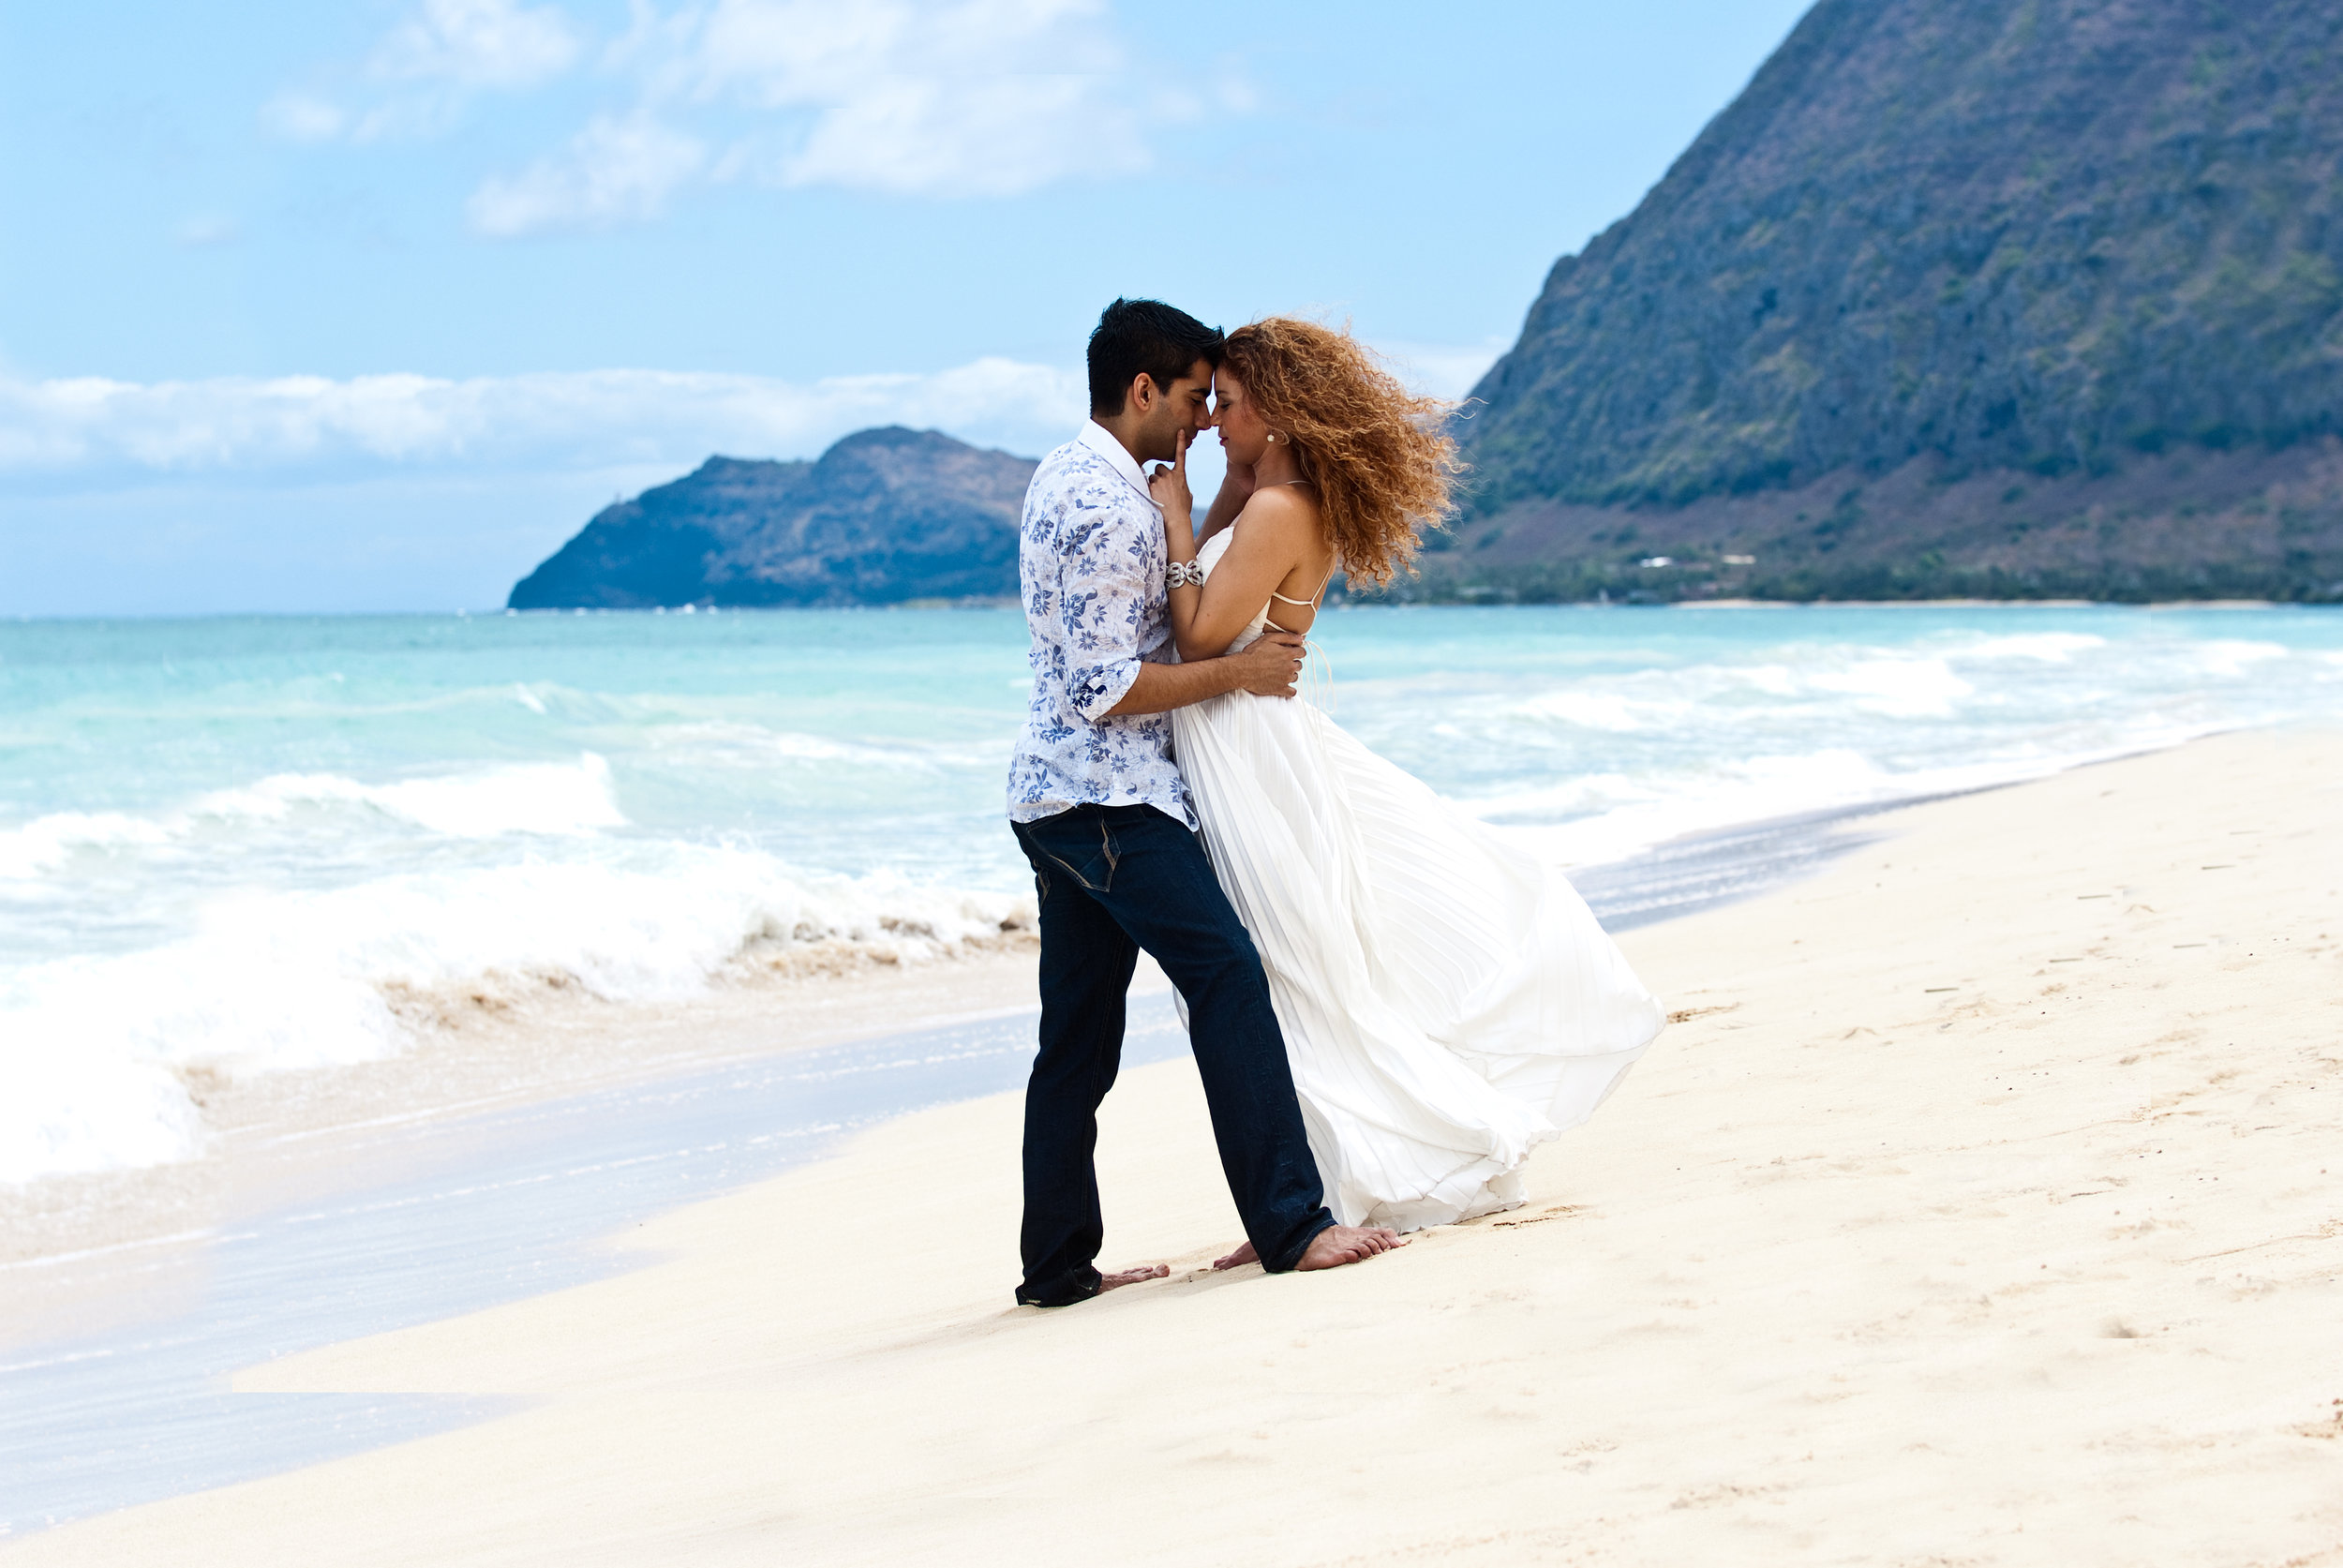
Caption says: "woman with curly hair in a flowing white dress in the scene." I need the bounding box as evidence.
[1153,317,1662,1265]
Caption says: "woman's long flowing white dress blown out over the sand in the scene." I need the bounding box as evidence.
[1172,528,1664,1231]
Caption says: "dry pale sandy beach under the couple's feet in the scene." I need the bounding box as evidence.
[0,729,2343,1565]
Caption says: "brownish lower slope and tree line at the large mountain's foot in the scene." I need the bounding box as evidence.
[1352,436,2343,605]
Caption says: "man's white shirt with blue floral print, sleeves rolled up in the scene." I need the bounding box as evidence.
[1010,420,1198,828]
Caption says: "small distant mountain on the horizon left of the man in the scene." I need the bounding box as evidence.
[509,426,1036,609]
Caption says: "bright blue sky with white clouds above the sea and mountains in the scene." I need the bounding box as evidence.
[0,0,1804,617]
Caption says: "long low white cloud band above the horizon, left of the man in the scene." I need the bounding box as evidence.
[0,359,1087,487]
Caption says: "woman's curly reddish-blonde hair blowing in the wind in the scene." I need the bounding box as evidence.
[1221,317,1465,589]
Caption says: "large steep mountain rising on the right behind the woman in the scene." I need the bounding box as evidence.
[1415,0,2343,600]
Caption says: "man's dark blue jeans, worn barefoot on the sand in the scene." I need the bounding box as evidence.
[1010,806,1334,1306]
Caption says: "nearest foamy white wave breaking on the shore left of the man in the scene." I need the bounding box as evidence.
[0,846,1034,1181]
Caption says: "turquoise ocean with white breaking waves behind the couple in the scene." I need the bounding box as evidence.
[0,605,2343,1181]
